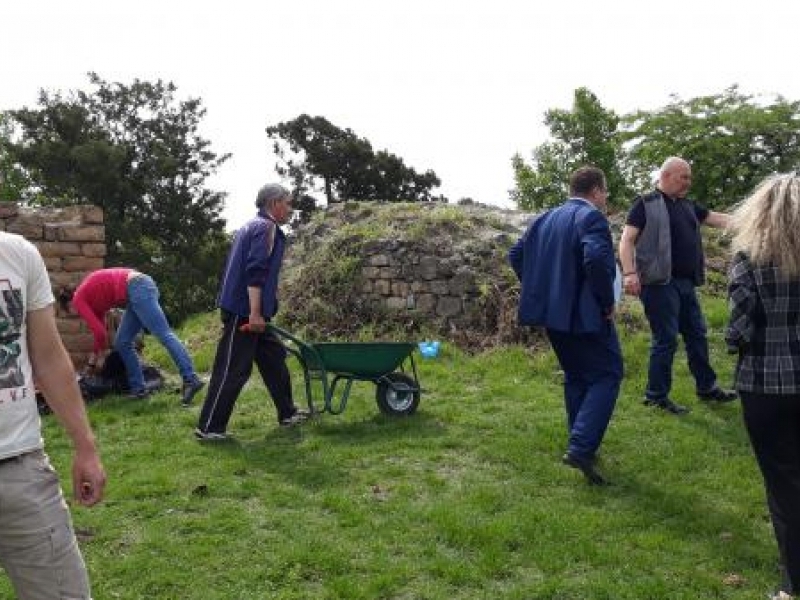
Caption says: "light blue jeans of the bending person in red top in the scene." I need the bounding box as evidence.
[114,275,197,392]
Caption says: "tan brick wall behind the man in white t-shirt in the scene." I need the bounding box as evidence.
[0,203,106,368]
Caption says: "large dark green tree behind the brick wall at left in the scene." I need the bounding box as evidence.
[9,73,229,319]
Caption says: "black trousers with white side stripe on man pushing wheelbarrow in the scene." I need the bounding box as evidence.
[198,312,297,433]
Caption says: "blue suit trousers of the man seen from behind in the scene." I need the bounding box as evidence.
[547,323,622,459]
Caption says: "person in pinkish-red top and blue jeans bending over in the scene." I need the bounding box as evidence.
[60,267,204,406]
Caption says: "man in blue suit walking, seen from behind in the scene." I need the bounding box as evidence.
[508,167,623,485]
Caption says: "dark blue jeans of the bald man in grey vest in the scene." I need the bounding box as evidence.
[640,279,717,400]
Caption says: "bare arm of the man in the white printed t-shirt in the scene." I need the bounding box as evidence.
[26,304,106,506]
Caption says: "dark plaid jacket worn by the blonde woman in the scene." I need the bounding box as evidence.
[725,253,800,394]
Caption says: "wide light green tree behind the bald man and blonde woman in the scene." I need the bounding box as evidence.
[624,86,800,209]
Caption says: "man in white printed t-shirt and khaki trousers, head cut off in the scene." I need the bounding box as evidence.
[0,232,106,599]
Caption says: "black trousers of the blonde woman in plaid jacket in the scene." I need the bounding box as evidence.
[739,392,800,591]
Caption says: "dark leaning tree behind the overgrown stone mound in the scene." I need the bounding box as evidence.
[267,114,441,209]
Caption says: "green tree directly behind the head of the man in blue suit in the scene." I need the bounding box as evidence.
[511,88,629,210]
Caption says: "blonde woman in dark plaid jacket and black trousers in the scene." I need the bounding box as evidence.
[725,173,800,598]
